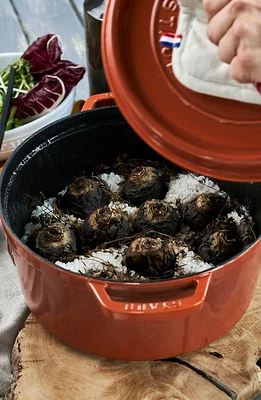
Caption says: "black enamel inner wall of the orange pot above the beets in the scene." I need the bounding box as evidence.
[1,106,261,252]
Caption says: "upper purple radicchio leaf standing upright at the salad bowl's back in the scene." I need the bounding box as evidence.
[22,33,62,75]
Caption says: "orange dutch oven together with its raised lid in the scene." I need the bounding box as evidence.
[0,0,261,360]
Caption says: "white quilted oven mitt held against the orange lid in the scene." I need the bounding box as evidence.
[172,0,261,104]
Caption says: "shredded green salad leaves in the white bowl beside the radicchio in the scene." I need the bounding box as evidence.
[0,58,36,130]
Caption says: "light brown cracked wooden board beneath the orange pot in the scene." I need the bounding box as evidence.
[7,275,261,400]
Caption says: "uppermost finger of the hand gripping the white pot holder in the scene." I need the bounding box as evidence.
[207,0,249,45]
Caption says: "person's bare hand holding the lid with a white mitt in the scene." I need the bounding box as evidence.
[203,0,261,83]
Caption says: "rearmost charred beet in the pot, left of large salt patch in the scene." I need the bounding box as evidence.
[122,166,162,205]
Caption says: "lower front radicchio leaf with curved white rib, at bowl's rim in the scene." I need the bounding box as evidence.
[11,75,66,122]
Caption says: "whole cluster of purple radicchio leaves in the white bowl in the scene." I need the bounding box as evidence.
[6,33,85,123]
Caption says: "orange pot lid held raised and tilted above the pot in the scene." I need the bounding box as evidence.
[102,0,261,182]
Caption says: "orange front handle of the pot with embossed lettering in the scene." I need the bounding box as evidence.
[88,273,212,320]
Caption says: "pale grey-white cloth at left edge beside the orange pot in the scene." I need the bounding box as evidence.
[0,223,29,398]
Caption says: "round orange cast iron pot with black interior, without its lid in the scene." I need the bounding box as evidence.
[1,94,261,360]
